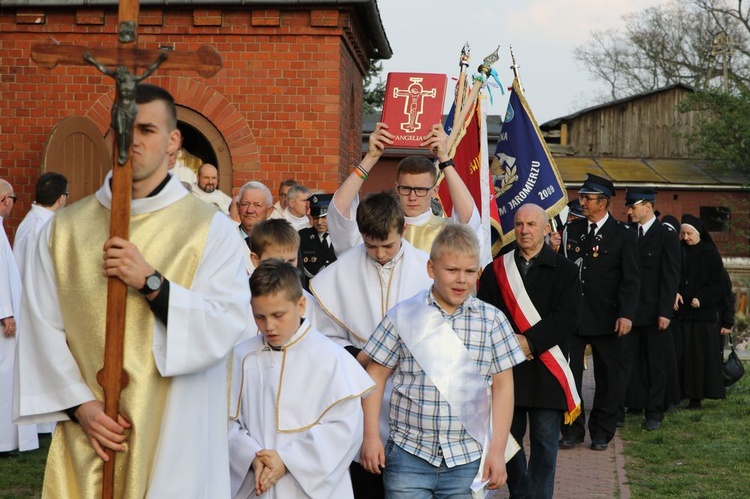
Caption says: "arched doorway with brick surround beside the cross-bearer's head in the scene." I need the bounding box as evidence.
[177,105,232,196]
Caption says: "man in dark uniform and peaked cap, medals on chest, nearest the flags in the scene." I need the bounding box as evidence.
[560,173,640,451]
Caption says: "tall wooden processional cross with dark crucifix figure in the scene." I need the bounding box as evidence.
[31,0,221,499]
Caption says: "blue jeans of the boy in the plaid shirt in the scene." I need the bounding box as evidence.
[383,440,479,499]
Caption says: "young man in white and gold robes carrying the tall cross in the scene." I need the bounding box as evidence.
[16,84,250,498]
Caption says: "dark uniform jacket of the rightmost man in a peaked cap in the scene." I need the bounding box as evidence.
[632,220,681,326]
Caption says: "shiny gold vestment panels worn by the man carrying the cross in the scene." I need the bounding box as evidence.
[42,195,216,499]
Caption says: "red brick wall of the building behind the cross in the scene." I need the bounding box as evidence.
[0,7,374,233]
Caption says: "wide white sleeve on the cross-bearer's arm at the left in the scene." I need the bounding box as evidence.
[14,224,95,424]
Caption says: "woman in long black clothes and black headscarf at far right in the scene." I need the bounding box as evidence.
[675,215,725,409]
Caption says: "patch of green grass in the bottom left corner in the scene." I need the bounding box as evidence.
[0,437,50,499]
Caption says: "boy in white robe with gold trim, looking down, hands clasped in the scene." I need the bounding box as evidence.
[229,259,373,499]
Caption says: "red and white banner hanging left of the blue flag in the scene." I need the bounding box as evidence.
[438,98,500,264]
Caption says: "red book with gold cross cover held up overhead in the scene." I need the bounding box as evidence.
[381,73,447,149]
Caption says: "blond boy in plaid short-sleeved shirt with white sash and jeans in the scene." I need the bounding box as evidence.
[361,225,526,498]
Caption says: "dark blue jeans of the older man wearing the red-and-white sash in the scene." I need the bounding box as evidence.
[506,407,563,499]
